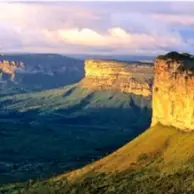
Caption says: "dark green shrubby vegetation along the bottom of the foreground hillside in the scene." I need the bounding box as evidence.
[1,169,194,194]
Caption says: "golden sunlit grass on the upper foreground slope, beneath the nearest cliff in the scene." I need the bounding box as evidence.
[54,125,194,180]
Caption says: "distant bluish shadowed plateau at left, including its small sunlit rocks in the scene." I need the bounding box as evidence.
[0,54,84,95]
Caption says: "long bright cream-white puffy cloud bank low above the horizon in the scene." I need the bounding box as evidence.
[42,27,182,51]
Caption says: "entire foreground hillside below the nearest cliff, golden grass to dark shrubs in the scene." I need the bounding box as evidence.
[2,125,194,194]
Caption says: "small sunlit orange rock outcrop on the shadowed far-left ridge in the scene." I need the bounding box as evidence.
[0,61,24,80]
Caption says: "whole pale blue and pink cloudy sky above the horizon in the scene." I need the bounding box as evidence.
[0,1,194,55]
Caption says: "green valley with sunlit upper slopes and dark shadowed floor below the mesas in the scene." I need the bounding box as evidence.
[0,84,151,184]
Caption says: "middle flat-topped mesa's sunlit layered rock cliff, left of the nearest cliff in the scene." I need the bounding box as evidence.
[81,59,153,96]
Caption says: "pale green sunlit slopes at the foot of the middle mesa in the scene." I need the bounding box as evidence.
[0,84,150,111]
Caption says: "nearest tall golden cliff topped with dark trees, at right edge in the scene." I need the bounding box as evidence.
[152,52,194,130]
